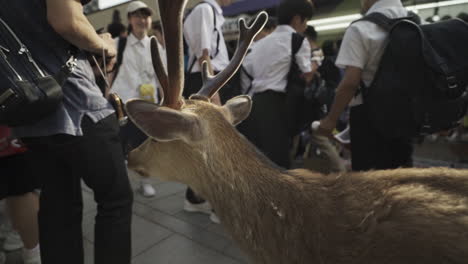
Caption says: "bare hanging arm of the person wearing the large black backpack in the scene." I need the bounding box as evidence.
[319,66,362,135]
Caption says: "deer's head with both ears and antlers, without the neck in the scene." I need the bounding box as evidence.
[125,0,268,188]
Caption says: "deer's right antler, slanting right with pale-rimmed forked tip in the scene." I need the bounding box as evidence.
[197,12,268,98]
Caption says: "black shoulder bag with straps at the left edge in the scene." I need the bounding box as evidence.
[0,19,75,127]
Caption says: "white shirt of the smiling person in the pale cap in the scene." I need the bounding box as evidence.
[112,34,166,102]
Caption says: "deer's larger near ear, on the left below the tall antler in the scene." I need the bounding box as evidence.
[125,100,204,142]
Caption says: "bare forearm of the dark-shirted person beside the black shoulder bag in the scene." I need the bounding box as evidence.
[47,0,117,57]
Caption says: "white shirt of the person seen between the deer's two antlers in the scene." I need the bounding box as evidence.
[184,0,229,72]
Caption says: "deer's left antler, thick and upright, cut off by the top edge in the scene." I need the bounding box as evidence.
[151,0,187,109]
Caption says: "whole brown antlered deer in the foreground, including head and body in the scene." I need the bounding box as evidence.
[125,0,468,264]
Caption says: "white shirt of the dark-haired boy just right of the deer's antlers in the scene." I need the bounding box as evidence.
[243,25,312,96]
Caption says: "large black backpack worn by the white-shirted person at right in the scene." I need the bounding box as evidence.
[361,13,468,138]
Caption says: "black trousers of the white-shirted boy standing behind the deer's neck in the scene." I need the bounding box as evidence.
[238,90,291,169]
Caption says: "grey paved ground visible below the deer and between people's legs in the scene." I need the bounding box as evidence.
[0,140,468,264]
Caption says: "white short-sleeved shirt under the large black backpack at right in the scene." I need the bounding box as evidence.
[336,0,408,106]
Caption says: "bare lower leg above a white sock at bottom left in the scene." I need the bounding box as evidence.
[6,193,39,249]
